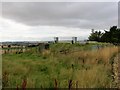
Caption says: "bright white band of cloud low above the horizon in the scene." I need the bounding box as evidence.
[0,18,90,41]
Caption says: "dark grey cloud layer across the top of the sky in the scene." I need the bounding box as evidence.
[2,2,118,29]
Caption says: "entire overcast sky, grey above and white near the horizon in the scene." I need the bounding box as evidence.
[0,2,118,41]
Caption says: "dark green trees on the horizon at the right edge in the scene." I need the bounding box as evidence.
[88,26,120,44]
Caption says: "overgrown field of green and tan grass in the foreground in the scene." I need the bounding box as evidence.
[2,43,118,88]
